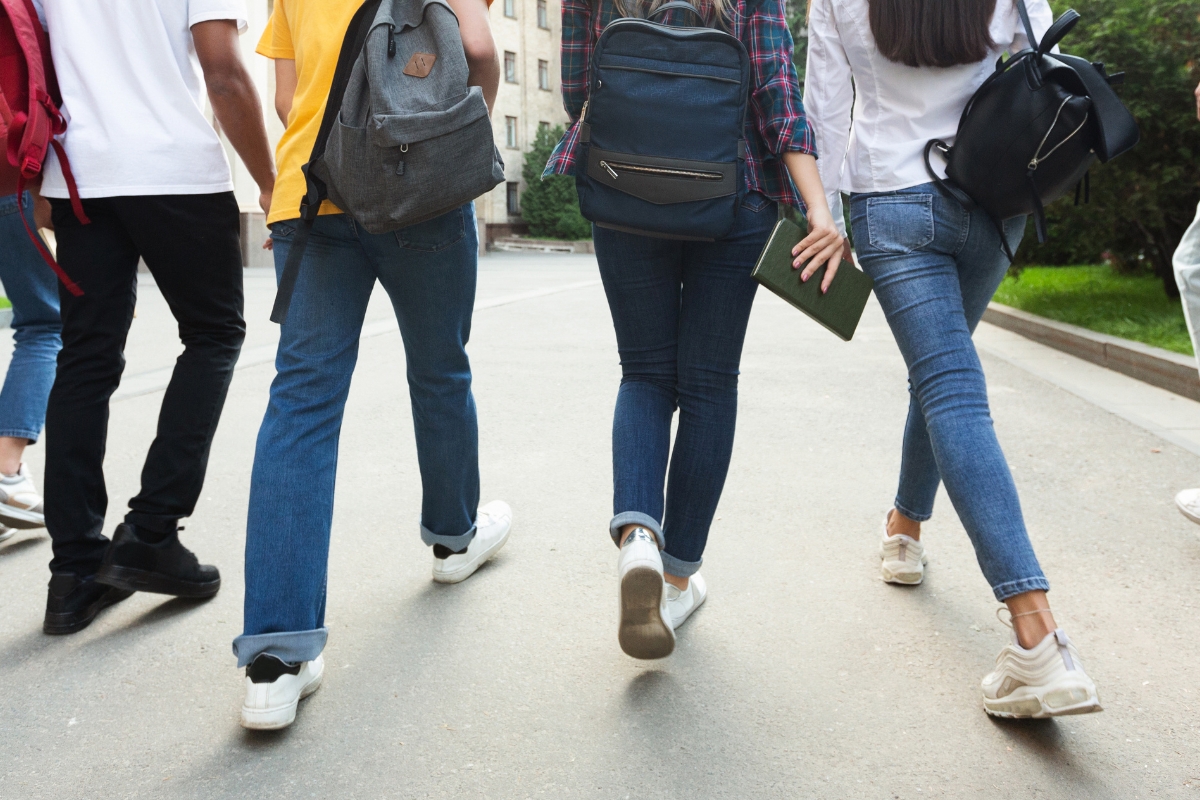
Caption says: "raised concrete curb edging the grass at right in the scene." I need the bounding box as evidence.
[983,302,1200,401]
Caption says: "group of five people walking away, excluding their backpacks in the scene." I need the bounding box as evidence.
[0,0,1147,728]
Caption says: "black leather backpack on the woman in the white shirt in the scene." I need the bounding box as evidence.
[925,0,1138,260]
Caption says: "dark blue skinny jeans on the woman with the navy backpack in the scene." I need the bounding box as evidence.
[593,193,778,577]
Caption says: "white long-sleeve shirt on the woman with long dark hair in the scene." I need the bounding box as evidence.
[804,0,1054,233]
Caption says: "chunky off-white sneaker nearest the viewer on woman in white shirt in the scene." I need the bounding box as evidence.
[983,627,1103,720]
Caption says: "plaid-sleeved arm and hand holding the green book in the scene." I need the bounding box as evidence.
[746,0,845,291]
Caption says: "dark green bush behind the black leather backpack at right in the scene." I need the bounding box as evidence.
[1018,0,1200,296]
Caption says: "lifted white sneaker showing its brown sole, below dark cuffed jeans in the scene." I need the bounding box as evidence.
[617,528,674,658]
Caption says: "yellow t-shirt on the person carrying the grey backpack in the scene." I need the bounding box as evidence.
[257,0,362,224]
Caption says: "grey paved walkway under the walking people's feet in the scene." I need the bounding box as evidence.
[0,254,1200,800]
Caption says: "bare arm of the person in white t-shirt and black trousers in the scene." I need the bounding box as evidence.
[192,19,275,211]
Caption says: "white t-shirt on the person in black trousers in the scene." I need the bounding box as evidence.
[35,0,247,198]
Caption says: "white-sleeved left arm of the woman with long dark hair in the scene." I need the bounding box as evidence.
[804,0,854,234]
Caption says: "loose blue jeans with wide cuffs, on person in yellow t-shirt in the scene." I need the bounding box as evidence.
[233,203,479,666]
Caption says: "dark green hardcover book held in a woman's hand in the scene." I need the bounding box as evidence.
[752,219,875,342]
